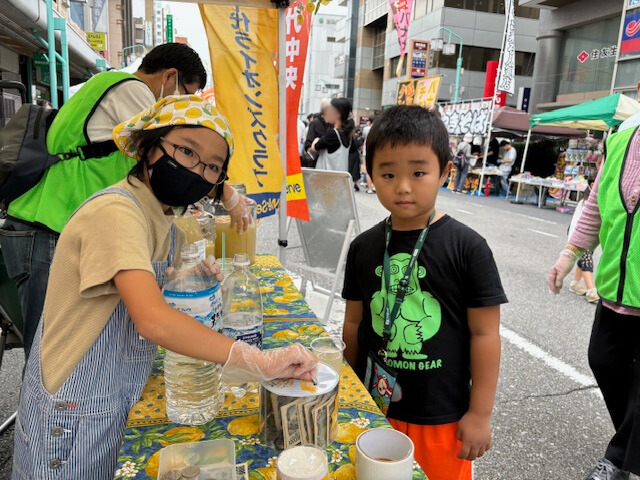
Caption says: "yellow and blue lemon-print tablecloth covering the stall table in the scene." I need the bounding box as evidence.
[115,256,426,480]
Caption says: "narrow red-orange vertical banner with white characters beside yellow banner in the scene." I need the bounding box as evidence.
[285,5,312,222]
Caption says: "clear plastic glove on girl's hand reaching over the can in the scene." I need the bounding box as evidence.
[222,342,318,383]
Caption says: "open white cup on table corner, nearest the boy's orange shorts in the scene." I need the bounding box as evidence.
[356,428,414,480]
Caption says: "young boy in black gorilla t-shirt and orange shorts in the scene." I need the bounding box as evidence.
[343,106,507,480]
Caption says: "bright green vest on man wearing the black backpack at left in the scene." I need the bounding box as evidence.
[8,72,140,233]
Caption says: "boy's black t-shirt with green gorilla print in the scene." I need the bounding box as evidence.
[342,215,507,425]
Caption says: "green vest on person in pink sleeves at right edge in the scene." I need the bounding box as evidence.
[596,128,640,308]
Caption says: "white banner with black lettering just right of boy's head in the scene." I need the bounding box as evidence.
[440,99,491,135]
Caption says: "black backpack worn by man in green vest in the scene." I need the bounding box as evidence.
[0,103,117,207]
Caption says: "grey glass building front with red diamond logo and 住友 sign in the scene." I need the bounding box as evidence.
[521,0,640,112]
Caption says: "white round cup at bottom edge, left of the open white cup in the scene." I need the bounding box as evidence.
[276,445,329,480]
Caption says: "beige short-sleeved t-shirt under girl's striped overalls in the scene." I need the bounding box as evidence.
[40,178,173,393]
